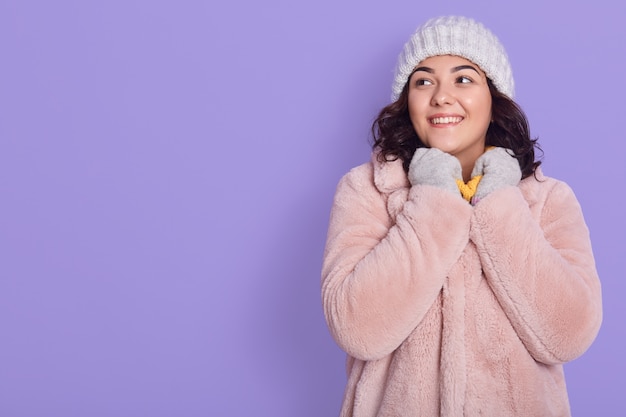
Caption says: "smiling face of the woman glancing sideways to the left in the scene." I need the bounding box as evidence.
[408,55,491,166]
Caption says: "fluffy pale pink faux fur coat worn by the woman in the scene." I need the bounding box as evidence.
[322,155,602,417]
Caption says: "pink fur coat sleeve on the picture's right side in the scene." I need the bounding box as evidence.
[470,179,602,364]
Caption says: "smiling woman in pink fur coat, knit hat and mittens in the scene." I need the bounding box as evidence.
[322,16,602,417]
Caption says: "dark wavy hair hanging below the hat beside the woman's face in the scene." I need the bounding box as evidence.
[372,79,543,178]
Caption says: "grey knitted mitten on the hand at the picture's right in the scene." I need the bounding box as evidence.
[472,148,522,204]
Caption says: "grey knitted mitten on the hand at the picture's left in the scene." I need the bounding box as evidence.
[408,148,462,196]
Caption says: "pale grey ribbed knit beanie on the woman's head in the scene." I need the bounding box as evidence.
[391,16,515,101]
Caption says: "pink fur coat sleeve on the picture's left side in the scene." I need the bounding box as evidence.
[322,165,471,360]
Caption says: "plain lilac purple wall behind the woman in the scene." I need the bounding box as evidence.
[0,0,626,417]
